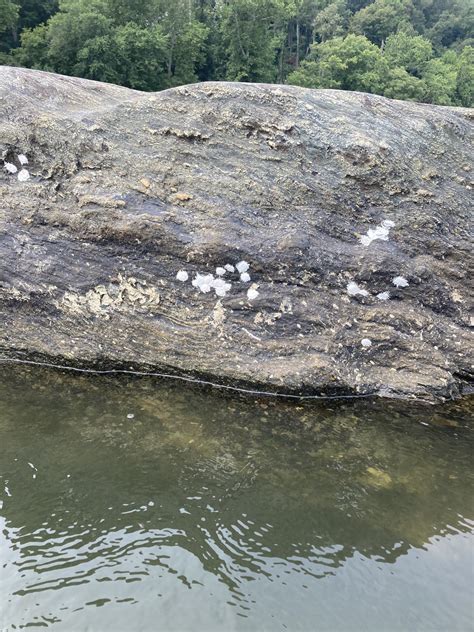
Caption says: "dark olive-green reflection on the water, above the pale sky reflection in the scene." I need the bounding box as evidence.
[0,362,473,589]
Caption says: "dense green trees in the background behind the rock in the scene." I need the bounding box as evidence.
[0,0,474,106]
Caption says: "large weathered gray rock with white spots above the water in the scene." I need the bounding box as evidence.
[0,67,474,400]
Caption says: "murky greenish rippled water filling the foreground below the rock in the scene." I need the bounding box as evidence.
[0,367,474,632]
